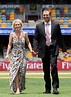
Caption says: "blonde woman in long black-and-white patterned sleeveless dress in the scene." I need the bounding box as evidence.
[6,19,33,94]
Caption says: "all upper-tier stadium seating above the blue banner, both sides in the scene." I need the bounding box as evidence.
[0,5,71,27]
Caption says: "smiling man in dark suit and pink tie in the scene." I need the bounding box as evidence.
[33,9,66,94]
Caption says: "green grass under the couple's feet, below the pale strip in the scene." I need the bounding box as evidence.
[0,78,71,97]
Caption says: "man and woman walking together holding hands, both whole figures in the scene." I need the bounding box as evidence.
[5,8,66,94]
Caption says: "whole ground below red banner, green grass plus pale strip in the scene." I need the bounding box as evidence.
[0,71,71,97]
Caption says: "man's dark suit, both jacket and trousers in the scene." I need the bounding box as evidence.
[33,21,66,91]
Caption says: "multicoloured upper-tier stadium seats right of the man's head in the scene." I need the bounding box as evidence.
[52,6,71,27]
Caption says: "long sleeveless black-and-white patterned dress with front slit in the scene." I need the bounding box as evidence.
[10,32,27,93]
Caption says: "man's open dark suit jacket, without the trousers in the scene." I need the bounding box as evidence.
[33,21,66,58]
